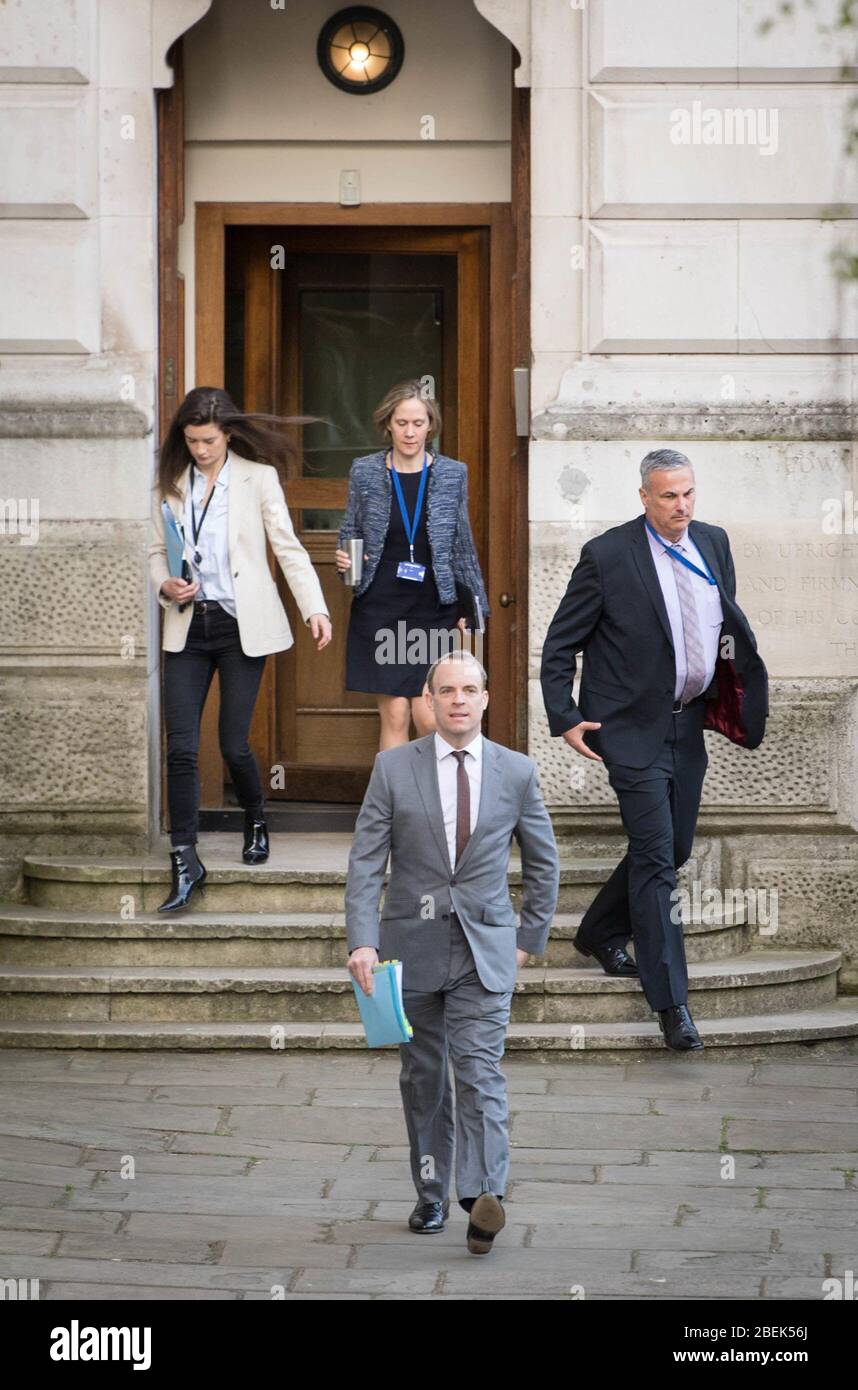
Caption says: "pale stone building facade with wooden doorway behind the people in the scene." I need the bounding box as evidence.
[0,0,858,980]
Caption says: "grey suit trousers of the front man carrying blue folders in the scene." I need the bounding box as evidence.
[399,913,512,1201]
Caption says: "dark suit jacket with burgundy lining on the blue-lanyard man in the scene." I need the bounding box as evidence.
[541,516,769,767]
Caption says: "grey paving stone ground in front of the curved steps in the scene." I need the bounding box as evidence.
[0,1045,858,1301]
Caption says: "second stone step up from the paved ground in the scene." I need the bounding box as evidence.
[0,949,841,1030]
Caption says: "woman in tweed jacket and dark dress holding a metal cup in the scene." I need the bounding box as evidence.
[337,381,488,748]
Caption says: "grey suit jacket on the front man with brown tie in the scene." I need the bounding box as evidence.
[345,734,559,992]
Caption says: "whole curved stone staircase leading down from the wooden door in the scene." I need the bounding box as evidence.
[0,834,858,1058]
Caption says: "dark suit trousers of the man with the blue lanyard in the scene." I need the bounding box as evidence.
[581,698,709,1011]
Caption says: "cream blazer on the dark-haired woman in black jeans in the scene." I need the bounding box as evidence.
[149,449,330,656]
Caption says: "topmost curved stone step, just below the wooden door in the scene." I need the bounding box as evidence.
[24,835,616,916]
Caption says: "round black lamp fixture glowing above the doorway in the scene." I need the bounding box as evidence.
[316,4,405,96]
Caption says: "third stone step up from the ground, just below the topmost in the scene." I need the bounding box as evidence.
[0,904,751,969]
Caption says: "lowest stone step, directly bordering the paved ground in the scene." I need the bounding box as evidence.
[0,998,858,1065]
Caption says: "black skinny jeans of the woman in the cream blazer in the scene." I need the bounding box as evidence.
[164,607,266,845]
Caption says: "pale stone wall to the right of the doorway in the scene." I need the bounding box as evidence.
[528,0,858,959]
